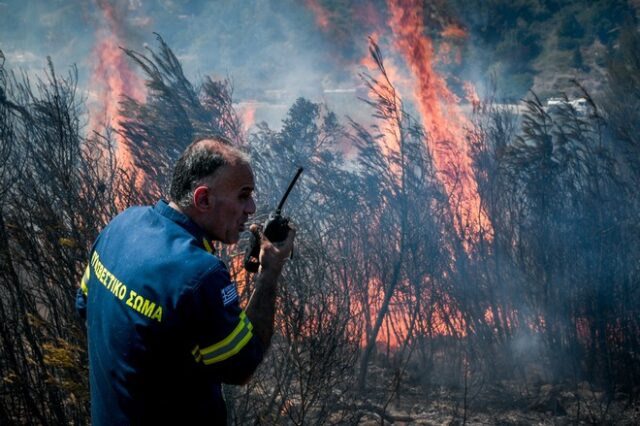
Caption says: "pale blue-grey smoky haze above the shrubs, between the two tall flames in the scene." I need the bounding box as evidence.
[0,0,384,126]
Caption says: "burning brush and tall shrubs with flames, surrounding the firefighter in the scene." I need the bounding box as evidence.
[0,0,640,424]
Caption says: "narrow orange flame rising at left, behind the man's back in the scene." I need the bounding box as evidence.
[89,1,145,187]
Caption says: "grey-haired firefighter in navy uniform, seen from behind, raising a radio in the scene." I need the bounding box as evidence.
[76,137,295,425]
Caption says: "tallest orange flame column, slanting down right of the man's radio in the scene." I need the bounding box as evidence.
[387,0,492,239]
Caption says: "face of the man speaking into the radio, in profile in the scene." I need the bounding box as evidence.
[201,163,256,244]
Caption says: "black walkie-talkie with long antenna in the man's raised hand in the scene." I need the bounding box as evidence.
[244,167,303,272]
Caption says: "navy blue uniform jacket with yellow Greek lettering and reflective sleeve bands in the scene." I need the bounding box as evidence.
[76,201,263,425]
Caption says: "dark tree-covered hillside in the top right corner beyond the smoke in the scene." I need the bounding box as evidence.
[452,0,640,98]
